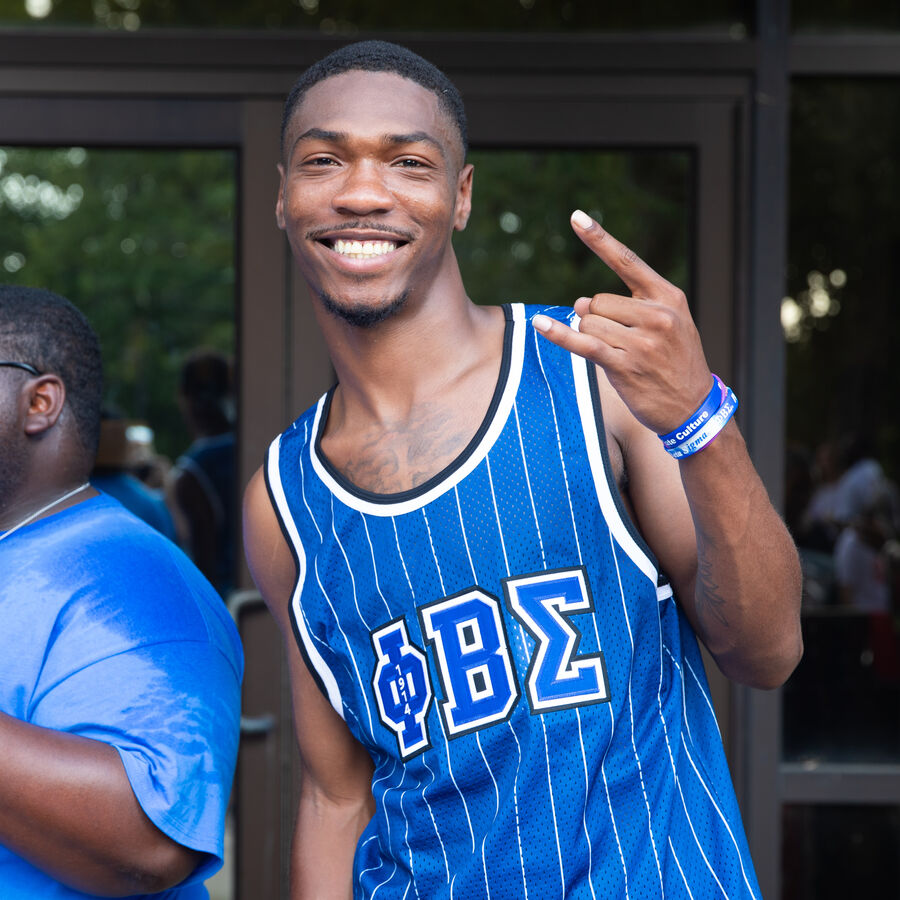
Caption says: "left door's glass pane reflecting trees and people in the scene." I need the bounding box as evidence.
[0,147,236,595]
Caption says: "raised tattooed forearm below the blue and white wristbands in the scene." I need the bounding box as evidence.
[679,422,802,688]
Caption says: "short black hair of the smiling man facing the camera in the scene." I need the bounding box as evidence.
[281,41,469,159]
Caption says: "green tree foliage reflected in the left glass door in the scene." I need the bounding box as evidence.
[0,148,235,456]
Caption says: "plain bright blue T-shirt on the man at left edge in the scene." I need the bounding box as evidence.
[0,495,243,900]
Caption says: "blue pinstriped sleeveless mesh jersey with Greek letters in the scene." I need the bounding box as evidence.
[266,305,759,900]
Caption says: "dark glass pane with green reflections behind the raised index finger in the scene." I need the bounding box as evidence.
[454,150,693,305]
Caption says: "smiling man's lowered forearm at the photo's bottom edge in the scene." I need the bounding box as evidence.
[291,782,374,900]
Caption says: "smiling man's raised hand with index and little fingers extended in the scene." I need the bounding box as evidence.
[534,210,713,434]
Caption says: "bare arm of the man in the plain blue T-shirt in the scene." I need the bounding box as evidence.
[0,713,196,897]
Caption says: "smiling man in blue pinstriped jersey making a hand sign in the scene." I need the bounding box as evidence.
[244,42,801,900]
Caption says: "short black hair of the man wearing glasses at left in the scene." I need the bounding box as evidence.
[0,284,103,456]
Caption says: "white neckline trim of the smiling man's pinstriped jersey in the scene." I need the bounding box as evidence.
[309,303,525,516]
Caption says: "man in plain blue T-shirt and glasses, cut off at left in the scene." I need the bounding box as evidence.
[0,285,243,900]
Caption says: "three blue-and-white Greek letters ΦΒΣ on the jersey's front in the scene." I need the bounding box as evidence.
[372,568,609,757]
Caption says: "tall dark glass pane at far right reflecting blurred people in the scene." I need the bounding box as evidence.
[782,80,900,765]
